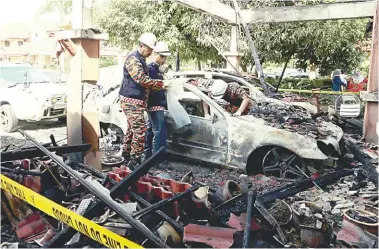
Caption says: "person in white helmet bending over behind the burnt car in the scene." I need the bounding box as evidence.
[203,80,251,117]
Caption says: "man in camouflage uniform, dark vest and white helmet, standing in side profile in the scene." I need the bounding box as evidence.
[119,33,169,169]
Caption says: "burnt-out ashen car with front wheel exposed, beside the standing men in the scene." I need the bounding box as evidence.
[100,78,343,178]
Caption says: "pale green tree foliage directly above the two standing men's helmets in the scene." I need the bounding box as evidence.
[99,0,230,61]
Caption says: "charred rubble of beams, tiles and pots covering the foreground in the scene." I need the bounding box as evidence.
[1,131,379,248]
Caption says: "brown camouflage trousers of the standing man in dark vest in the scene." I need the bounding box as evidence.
[121,101,146,161]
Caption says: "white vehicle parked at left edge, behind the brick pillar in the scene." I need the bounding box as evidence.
[0,64,67,132]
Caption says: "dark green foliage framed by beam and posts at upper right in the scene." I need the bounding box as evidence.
[240,17,366,75]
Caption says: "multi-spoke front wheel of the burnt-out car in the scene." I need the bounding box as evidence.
[262,147,307,180]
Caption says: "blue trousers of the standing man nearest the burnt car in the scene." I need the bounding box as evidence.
[145,111,167,159]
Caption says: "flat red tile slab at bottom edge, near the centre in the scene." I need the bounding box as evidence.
[183,224,237,248]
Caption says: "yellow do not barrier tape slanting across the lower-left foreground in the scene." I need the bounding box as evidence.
[0,175,143,248]
